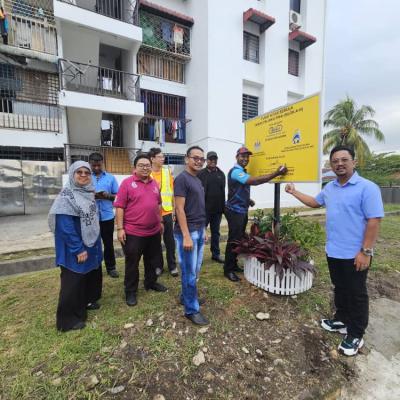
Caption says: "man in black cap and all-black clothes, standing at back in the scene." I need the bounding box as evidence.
[197,151,226,264]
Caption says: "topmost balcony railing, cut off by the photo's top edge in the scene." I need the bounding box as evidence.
[59,0,139,25]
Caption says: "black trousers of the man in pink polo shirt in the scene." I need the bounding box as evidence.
[123,233,161,293]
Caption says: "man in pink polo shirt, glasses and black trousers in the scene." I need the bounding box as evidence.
[114,154,167,306]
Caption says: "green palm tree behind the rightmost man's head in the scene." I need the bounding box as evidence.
[323,96,385,166]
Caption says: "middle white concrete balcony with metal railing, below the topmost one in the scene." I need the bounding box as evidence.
[59,59,144,119]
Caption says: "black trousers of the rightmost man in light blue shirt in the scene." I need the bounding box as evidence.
[327,257,369,338]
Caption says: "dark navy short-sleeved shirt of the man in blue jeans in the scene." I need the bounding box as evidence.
[174,171,206,232]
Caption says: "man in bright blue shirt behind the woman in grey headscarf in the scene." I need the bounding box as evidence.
[89,153,118,278]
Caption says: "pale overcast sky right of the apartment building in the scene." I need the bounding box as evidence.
[325,0,400,151]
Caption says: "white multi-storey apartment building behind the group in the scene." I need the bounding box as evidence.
[0,0,325,214]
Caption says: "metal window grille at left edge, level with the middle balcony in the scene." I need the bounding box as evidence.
[0,64,62,132]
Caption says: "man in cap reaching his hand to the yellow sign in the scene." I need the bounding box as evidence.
[224,147,287,282]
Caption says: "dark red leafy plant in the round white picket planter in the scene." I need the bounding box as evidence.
[232,228,315,280]
